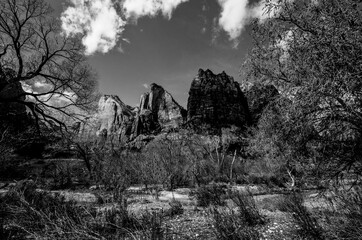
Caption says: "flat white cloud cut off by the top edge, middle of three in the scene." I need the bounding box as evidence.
[123,0,189,20]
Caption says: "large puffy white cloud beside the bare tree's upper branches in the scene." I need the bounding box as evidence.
[61,0,126,55]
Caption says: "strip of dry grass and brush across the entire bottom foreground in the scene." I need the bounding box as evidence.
[0,181,362,240]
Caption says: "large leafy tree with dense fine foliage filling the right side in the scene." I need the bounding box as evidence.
[246,0,362,182]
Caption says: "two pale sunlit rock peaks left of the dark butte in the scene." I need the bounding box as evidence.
[80,84,186,143]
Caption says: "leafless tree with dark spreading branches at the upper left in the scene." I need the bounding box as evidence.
[0,0,96,128]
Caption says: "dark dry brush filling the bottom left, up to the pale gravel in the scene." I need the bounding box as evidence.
[0,182,176,240]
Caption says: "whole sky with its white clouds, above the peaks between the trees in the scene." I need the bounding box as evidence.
[47,0,265,107]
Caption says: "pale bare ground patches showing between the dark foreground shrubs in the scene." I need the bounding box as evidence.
[2,186,322,240]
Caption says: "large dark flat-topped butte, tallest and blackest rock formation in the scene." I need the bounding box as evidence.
[187,69,250,133]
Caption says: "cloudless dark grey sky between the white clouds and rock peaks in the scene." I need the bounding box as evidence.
[48,0,264,106]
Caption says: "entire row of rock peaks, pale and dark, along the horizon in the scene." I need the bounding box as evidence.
[78,69,272,145]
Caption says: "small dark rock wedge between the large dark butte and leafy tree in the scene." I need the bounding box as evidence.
[245,85,279,124]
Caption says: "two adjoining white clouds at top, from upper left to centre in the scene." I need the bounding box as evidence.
[61,0,189,55]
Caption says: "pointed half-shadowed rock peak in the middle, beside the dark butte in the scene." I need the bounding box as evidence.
[133,83,186,136]
